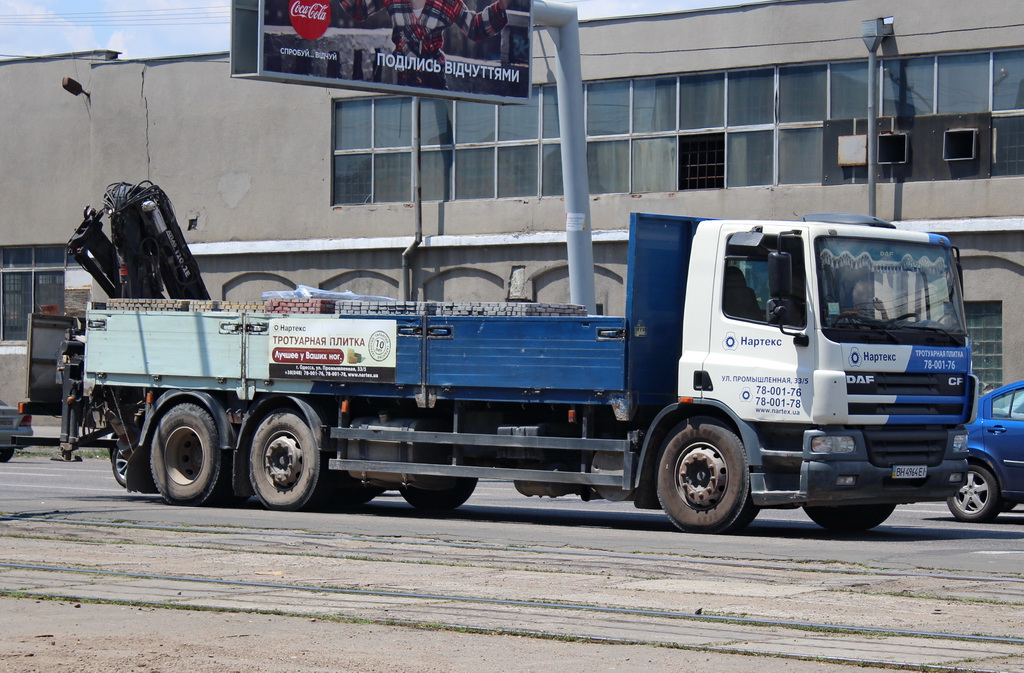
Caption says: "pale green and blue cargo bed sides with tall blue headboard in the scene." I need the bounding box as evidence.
[87,214,699,405]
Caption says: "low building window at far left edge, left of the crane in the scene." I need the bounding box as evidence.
[0,246,68,341]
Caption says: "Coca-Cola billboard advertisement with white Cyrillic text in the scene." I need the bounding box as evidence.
[258,0,532,102]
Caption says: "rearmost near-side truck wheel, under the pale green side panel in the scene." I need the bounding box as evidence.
[150,404,231,506]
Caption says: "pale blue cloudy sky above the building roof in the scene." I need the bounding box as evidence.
[0,0,757,58]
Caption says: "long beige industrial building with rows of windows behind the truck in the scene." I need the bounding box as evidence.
[0,0,1024,402]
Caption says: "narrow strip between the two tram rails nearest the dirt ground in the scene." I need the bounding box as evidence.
[0,563,1024,673]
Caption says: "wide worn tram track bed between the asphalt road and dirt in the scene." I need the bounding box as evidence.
[0,516,1024,671]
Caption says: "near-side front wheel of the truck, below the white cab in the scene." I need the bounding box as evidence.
[657,417,758,533]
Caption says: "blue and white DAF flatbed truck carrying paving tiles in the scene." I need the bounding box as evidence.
[25,201,978,533]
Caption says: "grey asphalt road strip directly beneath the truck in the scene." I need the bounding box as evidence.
[0,455,1024,575]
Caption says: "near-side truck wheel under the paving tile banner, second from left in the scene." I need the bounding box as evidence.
[249,409,329,511]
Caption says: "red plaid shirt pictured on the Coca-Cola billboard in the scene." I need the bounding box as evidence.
[341,0,508,60]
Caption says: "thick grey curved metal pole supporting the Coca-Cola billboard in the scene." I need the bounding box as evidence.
[534,0,597,313]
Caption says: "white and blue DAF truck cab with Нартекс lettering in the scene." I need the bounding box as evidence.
[677,215,977,528]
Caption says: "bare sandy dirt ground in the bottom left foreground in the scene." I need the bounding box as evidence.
[0,598,913,673]
